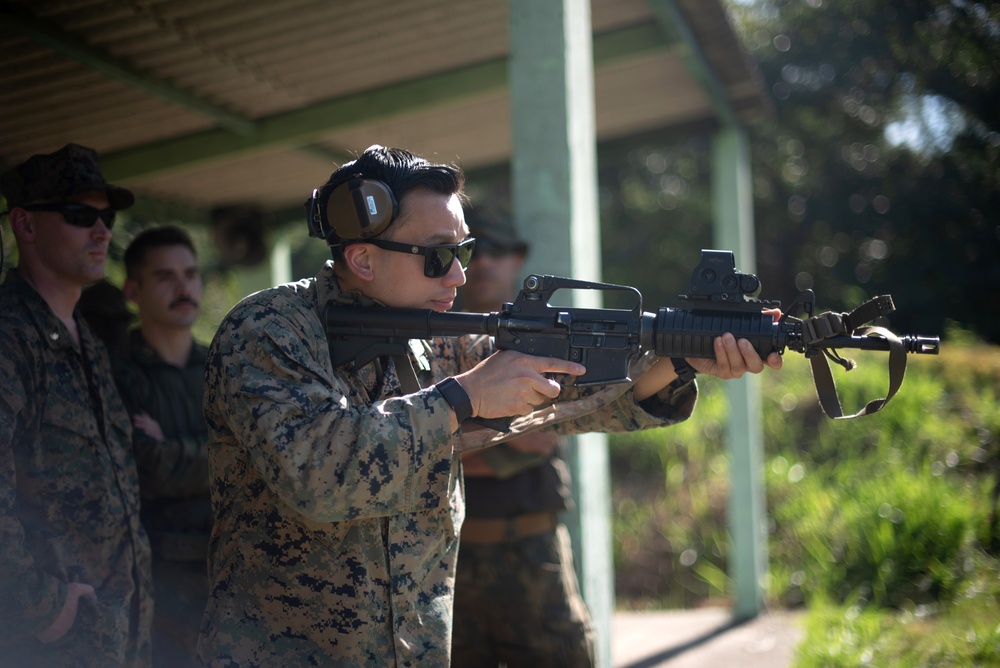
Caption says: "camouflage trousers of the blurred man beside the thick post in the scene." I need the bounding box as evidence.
[452,525,594,668]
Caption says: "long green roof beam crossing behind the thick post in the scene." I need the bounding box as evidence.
[101,24,671,182]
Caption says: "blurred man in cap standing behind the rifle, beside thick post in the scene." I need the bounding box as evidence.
[452,206,594,668]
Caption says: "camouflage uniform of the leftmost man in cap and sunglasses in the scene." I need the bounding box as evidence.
[0,269,153,666]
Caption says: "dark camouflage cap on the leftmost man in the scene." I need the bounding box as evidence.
[0,144,135,211]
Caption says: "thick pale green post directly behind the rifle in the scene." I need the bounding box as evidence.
[509,0,614,667]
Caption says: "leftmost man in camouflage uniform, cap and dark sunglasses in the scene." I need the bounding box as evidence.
[0,144,153,667]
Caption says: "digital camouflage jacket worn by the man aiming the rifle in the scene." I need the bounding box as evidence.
[199,262,693,668]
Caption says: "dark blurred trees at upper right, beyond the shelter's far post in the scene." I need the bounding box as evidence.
[733,0,1000,342]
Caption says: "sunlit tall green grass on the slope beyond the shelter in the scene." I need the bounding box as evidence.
[611,337,1000,666]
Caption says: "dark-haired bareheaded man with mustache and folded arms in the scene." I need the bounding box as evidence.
[115,226,212,668]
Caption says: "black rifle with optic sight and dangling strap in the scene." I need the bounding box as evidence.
[326,250,941,418]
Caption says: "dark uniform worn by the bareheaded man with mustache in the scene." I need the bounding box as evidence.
[115,329,212,668]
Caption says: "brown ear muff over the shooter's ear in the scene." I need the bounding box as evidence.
[309,176,399,243]
